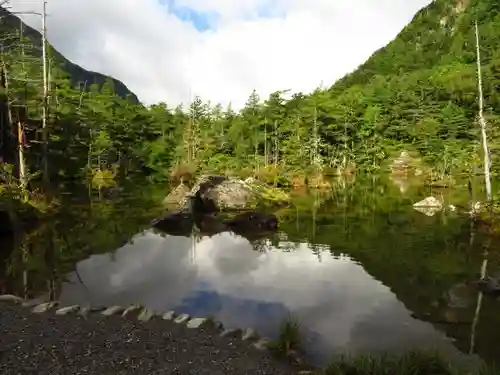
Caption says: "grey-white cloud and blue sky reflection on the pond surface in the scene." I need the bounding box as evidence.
[61,232,464,364]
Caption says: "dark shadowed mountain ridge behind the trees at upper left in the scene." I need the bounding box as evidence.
[0,7,139,103]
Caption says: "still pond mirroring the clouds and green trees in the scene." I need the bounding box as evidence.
[0,178,500,370]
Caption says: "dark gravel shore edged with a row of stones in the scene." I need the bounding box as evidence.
[0,303,295,375]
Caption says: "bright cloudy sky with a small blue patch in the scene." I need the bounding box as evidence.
[10,0,431,107]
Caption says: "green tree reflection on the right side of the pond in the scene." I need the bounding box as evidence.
[276,179,500,368]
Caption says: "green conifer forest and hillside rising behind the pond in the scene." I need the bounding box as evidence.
[2,0,500,191]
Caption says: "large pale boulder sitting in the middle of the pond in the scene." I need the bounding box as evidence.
[164,176,290,212]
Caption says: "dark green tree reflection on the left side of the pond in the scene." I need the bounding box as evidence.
[4,182,162,298]
